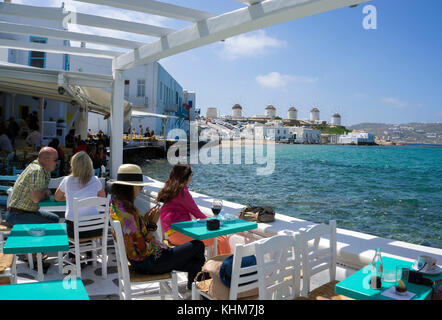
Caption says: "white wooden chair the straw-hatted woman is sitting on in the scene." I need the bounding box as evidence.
[110,219,179,300]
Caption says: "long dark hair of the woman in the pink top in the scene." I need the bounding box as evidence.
[157,163,192,204]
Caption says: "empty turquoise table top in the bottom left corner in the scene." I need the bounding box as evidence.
[0,278,89,300]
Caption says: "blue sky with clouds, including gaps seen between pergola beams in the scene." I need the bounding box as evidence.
[6,0,442,125]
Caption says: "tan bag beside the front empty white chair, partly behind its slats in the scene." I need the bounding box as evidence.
[194,254,258,300]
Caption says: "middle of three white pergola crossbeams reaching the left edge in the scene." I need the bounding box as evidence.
[0,21,143,49]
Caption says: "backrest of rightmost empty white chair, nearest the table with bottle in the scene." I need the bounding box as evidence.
[299,220,336,296]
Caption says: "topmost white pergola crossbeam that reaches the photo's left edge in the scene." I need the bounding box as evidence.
[0,2,176,37]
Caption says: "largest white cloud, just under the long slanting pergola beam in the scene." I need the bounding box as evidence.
[221,30,287,60]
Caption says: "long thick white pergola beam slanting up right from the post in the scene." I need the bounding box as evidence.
[114,0,370,70]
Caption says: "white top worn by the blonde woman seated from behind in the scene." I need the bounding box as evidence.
[60,176,103,221]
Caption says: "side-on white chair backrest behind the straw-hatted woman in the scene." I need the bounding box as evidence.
[110,219,131,298]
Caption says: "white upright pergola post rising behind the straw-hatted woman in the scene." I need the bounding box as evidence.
[108,69,124,179]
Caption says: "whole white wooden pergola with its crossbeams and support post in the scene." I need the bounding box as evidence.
[0,0,369,178]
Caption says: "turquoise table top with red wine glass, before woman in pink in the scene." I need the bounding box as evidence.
[171,219,258,240]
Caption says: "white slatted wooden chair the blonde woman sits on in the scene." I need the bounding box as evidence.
[58,196,110,279]
